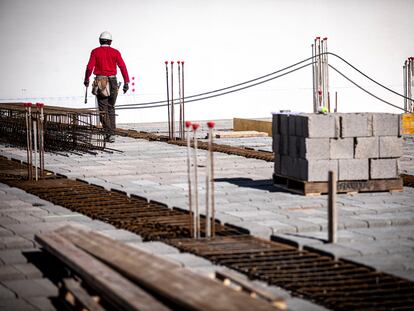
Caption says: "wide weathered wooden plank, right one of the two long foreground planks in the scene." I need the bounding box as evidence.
[59,228,274,311]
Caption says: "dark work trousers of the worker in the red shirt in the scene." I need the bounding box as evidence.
[96,77,118,135]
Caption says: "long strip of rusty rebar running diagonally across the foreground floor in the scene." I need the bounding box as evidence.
[0,158,414,310]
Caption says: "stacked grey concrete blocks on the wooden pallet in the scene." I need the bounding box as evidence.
[272,113,402,182]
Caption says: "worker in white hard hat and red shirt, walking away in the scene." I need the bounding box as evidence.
[83,31,129,142]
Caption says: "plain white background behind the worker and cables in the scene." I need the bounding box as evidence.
[0,0,414,122]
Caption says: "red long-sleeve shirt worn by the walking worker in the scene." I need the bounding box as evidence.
[85,45,129,83]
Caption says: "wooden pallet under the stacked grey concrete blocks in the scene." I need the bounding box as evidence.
[273,174,403,196]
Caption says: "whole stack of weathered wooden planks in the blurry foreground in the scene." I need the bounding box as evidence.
[36,226,284,311]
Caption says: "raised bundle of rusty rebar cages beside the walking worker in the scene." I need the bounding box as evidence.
[0,103,105,152]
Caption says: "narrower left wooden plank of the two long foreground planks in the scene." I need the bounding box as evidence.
[36,232,170,311]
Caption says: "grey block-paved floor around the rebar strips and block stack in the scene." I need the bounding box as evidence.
[0,120,414,310]
